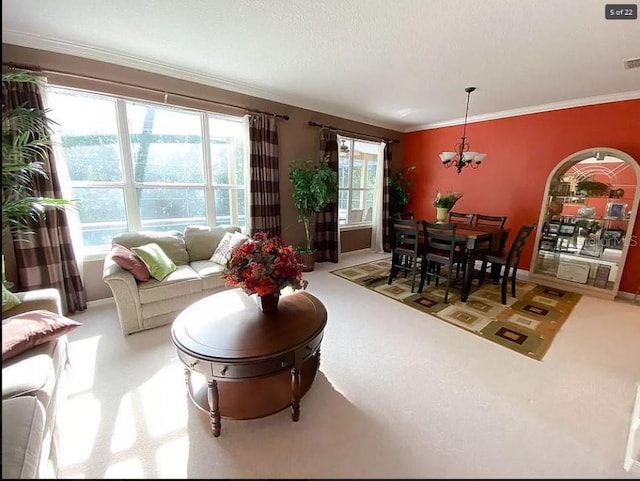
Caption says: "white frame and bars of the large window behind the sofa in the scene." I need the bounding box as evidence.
[47,83,250,260]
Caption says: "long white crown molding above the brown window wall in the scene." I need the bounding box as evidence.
[2,30,402,132]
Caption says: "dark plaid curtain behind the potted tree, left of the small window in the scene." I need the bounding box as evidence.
[314,129,339,262]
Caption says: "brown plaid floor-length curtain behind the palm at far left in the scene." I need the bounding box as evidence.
[3,77,87,313]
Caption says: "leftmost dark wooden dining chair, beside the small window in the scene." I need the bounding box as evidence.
[387,218,424,292]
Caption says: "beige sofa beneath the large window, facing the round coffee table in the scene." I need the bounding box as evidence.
[103,226,240,334]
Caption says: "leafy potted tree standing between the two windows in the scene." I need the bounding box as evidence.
[289,157,338,272]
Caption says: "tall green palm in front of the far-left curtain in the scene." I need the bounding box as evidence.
[2,72,72,236]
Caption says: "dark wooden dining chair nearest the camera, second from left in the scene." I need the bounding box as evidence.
[418,221,466,304]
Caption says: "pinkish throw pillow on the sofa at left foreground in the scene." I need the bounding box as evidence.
[2,309,82,361]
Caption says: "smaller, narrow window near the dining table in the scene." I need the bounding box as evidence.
[338,135,380,227]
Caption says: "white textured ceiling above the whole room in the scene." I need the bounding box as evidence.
[2,0,640,131]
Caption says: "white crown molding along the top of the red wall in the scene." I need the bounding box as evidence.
[403,90,640,134]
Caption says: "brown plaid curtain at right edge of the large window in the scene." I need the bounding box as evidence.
[249,114,282,236]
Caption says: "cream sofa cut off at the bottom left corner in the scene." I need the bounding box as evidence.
[2,289,69,479]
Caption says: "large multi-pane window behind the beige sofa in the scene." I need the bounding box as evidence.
[47,86,248,252]
